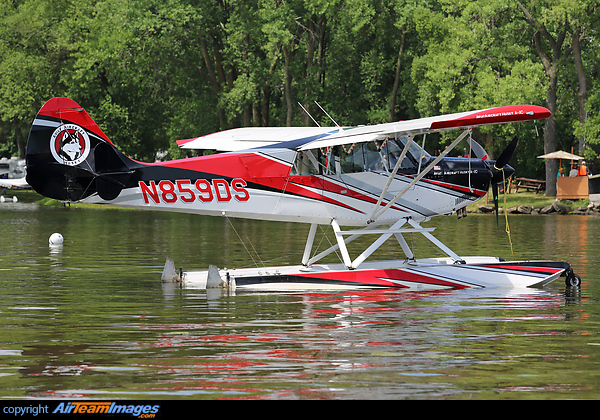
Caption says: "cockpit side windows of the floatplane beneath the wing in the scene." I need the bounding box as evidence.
[292,136,431,175]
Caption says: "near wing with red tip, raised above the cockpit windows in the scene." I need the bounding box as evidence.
[298,105,550,150]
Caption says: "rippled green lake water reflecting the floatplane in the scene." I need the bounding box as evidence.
[0,204,600,400]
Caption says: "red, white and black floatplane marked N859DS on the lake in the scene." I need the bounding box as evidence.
[26,98,580,291]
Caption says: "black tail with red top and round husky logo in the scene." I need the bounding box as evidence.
[26,97,139,201]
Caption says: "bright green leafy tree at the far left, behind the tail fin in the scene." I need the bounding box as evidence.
[0,0,71,158]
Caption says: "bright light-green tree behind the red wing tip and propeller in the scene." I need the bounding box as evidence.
[412,0,546,176]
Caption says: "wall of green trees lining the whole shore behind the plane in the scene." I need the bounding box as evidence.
[0,0,600,185]
